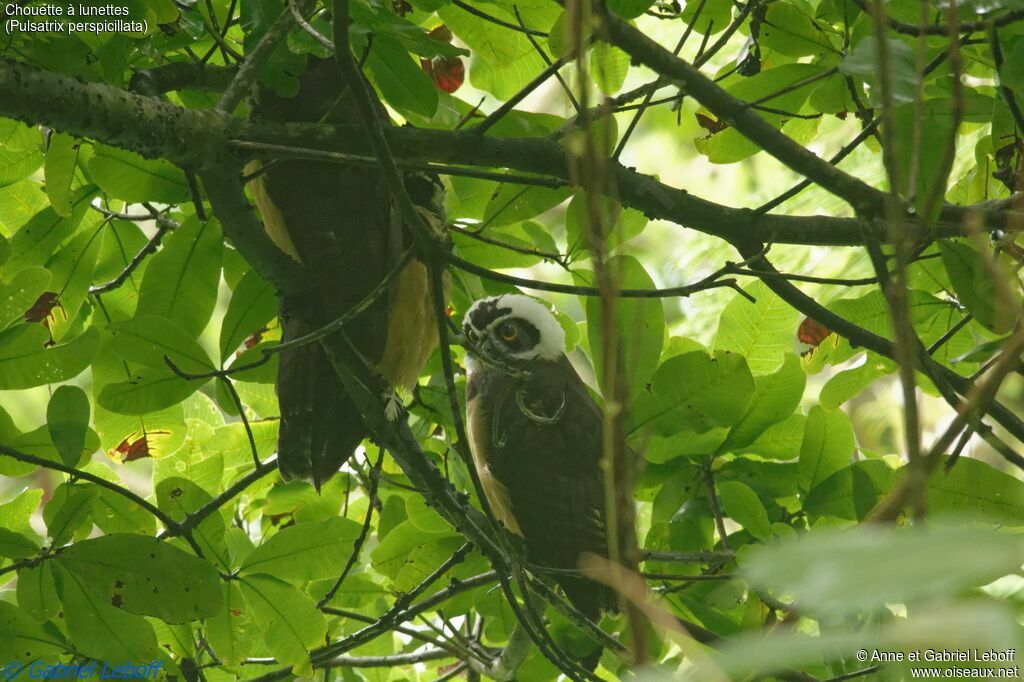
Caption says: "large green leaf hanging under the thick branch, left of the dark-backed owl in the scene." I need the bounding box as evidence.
[138,217,223,338]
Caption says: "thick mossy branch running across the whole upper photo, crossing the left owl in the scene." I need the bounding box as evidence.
[0,54,1022,246]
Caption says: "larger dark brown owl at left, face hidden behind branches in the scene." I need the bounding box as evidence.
[246,57,450,489]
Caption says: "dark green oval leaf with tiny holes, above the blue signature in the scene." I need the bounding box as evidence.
[54,534,221,623]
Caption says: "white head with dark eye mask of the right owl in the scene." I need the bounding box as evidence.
[463,294,565,360]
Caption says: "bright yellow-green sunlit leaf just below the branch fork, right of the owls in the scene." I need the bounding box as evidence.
[715,281,800,376]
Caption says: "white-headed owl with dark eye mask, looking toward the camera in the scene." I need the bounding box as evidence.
[463,294,613,620]
